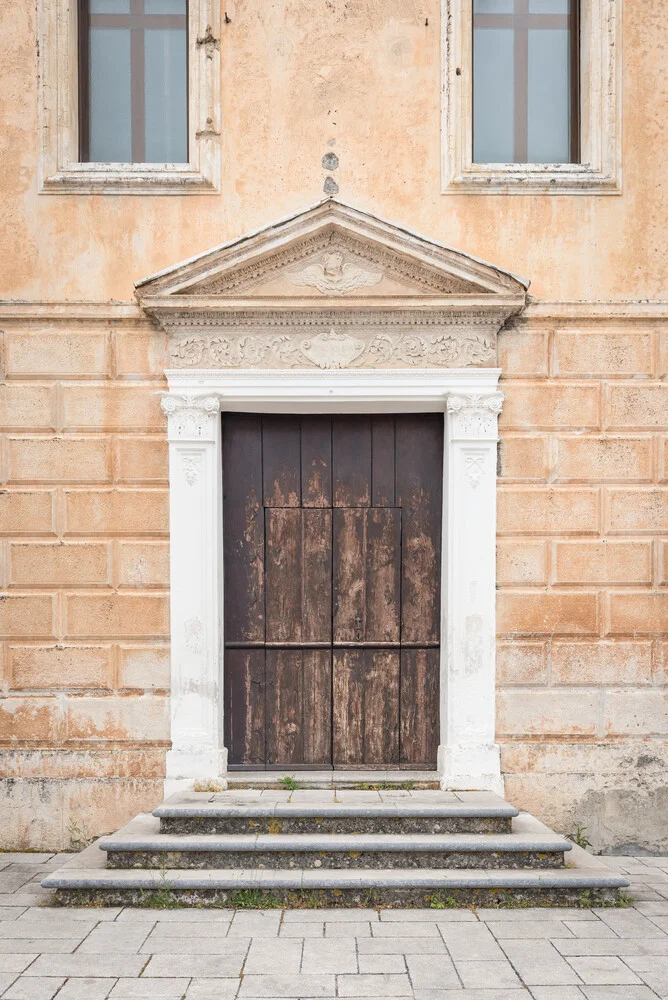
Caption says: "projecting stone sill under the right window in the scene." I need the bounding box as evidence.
[441,163,622,195]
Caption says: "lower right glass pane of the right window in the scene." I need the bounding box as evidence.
[527,29,570,163]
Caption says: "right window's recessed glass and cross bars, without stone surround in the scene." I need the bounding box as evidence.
[473,0,579,163]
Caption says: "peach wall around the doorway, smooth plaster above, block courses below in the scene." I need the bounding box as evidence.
[0,0,668,847]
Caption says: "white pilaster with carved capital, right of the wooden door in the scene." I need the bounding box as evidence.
[438,392,503,794]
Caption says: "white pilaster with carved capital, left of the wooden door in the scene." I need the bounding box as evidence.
[162,392,227,794]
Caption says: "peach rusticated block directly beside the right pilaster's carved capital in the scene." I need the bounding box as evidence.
[499,382,600,431]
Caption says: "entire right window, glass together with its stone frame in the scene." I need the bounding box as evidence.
[442,0,621,194]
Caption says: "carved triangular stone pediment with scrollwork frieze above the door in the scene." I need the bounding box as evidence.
[136,200,528,369]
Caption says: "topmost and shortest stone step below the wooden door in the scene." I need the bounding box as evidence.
[153,788,518,834]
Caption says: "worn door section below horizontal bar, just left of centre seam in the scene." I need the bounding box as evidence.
[267,649,332,767]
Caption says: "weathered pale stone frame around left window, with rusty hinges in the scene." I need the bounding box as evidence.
[38,0,221,194]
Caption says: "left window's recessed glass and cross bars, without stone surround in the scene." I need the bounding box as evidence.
[79,0,188,163]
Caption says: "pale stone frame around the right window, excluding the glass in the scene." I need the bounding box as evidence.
[441,0,622,194]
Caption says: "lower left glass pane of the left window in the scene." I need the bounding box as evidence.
[90,28,132,163]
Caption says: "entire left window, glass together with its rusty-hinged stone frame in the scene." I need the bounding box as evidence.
[37,0,221,194]
